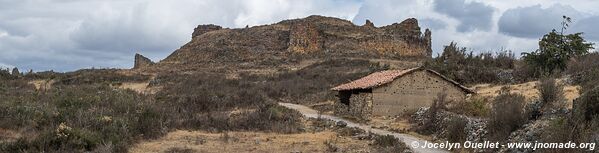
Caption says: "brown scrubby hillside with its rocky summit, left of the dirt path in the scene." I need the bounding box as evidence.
[0,16,431,152]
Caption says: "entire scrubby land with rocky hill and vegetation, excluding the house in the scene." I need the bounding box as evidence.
[0,16,599,153]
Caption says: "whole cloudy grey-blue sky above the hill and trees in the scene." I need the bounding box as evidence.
[0,0,599,71]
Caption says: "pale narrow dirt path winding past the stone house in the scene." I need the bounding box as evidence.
[279,103,448,153]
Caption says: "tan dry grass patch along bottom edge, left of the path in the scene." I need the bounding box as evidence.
[130,130,370,153]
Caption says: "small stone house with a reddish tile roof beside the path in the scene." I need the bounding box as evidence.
[331,67,475,119]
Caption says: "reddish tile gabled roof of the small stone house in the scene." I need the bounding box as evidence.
[331,67,475,93]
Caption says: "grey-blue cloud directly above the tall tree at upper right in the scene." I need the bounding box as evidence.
[498,4,582,38]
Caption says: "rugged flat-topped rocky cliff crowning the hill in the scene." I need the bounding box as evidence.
[160,16,431,68]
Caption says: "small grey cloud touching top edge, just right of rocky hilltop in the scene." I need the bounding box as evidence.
[434,0,495,32]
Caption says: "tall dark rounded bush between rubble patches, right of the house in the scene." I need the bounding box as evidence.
[487,89,526,141]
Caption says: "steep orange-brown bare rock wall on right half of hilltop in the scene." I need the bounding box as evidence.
[287,19,432,58]
